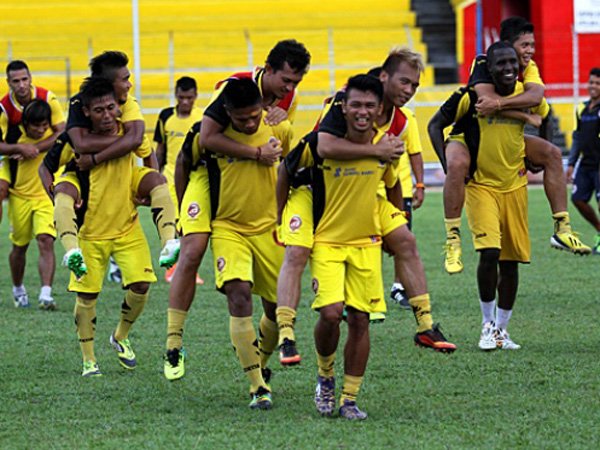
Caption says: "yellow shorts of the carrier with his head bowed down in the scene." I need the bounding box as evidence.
[210,226,285,303]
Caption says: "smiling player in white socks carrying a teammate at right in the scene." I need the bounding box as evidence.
[429,41,549,350]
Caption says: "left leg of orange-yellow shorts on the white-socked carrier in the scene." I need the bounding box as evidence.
[465,185,501,250]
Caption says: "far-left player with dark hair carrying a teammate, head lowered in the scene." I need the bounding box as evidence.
[0,99,56,310]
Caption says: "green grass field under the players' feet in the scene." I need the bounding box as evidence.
[0,189,600,449]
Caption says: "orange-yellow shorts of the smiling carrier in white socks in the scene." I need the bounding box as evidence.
[465,183,531,263]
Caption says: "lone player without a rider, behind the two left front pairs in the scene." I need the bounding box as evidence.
[154,77,202,284]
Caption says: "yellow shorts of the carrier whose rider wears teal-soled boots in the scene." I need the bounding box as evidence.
[69,221,156,294]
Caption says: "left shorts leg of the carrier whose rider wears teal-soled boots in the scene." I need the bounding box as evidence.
[69,238,113,294]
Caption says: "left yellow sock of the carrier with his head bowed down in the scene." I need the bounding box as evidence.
[229,316,270,392]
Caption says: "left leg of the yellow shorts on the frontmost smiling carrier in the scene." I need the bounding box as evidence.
[310,244,347,310]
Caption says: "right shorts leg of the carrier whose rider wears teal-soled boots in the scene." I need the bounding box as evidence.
[112,221,156,287]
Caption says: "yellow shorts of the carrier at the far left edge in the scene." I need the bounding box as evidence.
[8,194,56,247]
